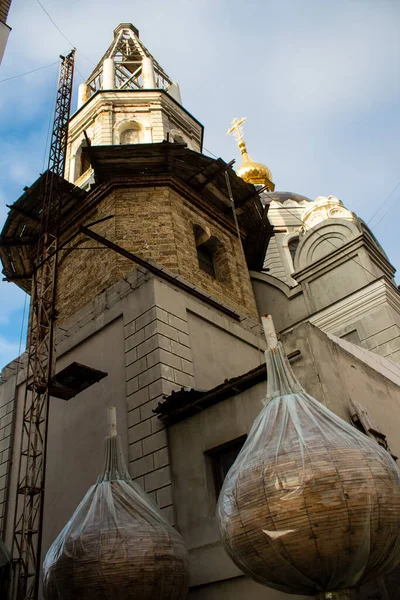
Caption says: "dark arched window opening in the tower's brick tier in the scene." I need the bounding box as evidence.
[193,225,227,280]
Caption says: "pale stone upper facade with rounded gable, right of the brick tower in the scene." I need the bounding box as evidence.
[252,192,400,362]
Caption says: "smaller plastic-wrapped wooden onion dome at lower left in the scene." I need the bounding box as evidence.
[43,409,188,600]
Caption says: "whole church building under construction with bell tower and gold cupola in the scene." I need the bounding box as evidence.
[0,23,400,600]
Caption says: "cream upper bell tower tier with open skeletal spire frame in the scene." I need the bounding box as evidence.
[66,23,203,189]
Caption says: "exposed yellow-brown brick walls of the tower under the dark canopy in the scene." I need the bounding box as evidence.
[57,186,257,322]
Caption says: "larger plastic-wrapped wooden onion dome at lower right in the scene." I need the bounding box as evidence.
[218,317,400,598]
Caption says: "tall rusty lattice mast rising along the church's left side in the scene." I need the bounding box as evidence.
[11,50,75,600]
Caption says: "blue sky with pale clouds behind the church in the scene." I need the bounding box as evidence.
[0,0,400,368]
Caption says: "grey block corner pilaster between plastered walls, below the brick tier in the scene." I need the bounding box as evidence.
[124,306,194,523]
